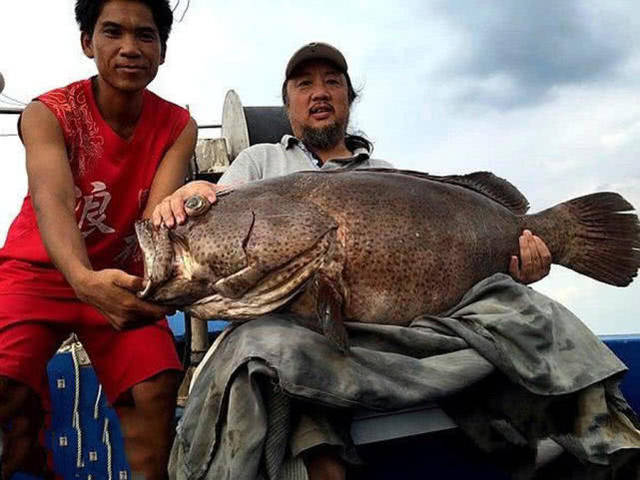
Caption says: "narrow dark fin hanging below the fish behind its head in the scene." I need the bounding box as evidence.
[313,276,349,353]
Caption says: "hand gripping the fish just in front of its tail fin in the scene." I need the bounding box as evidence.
[509,230,551,285]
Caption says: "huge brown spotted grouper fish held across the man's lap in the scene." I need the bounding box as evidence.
[136,169,640,348]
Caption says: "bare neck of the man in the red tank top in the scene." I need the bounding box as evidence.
[92,77,143,139]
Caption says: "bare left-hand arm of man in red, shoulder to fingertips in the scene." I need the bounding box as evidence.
[21,102,168,329]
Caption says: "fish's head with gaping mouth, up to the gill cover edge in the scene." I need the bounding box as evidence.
[136,186,337,320]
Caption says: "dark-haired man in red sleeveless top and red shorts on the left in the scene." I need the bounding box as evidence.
[0,0,197,480]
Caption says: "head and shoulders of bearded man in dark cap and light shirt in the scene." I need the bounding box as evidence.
[214,43,393,185]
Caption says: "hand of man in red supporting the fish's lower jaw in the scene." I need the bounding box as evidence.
[74,269,174,331]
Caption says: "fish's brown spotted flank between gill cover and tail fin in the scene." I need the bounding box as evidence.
[278,171,520,325]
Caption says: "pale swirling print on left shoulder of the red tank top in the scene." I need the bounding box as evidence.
[40,82,104,176]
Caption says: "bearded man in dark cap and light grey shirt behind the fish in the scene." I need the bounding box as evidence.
[152,42,551,480]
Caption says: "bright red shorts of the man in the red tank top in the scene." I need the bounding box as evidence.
[0,294,182,405]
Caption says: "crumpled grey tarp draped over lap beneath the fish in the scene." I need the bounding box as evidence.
[170,274,640,480]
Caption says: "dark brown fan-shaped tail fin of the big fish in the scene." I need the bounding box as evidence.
[523,192,640,287]
